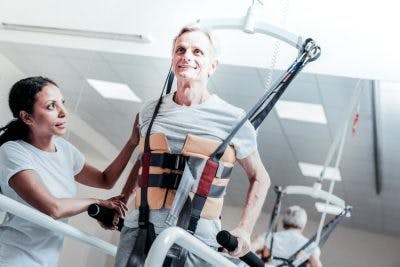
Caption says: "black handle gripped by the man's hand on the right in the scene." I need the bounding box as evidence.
[217,230,264,267]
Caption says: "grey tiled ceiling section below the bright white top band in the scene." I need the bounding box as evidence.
[0,42,400,239]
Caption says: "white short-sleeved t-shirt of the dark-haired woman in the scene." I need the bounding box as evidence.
[0,138,85,267]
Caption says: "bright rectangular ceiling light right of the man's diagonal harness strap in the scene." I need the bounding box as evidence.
[275,100,327,124]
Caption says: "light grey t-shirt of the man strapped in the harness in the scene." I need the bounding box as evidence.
[125,94,257,247]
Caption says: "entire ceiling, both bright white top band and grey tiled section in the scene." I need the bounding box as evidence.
[0,0,400,239]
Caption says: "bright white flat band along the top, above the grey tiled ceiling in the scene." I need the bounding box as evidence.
[0,0,400,81]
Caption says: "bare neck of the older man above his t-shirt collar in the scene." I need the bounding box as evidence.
[174,81,210,106]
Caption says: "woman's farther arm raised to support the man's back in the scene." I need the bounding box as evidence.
[75,114,140,189]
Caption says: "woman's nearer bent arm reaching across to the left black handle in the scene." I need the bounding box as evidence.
[9,170,126,219]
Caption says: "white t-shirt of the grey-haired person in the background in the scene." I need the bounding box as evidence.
[265,229,319,265]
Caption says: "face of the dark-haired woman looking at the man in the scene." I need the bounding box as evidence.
[28,84,67,136]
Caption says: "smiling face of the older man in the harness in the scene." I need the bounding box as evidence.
[172,31,217,81]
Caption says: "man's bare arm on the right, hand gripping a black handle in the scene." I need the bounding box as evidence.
[231,151,271,257]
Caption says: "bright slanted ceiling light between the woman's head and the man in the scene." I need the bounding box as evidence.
[87,79,142,103]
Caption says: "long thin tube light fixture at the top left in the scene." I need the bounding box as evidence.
[1,22,151,43]
